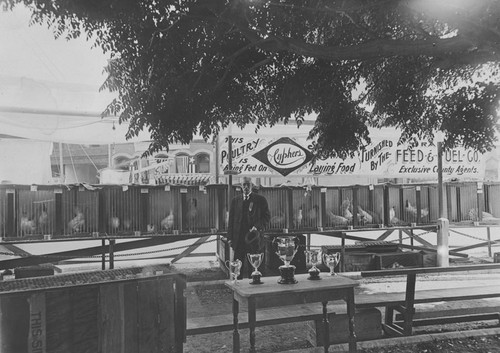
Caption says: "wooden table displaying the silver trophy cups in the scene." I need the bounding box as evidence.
[225,273,358,352]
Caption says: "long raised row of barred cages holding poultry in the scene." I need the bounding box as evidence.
[0,182,500,238]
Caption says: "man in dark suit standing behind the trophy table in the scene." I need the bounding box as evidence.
[227,177,271,278]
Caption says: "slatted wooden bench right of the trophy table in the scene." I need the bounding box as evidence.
[362,263,500,335]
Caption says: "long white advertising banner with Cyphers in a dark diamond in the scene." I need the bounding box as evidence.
[219,135,484,179]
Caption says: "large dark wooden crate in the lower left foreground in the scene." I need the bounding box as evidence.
[0,266,186,353]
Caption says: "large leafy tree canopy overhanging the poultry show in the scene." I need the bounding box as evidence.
[4,0,500,157]
